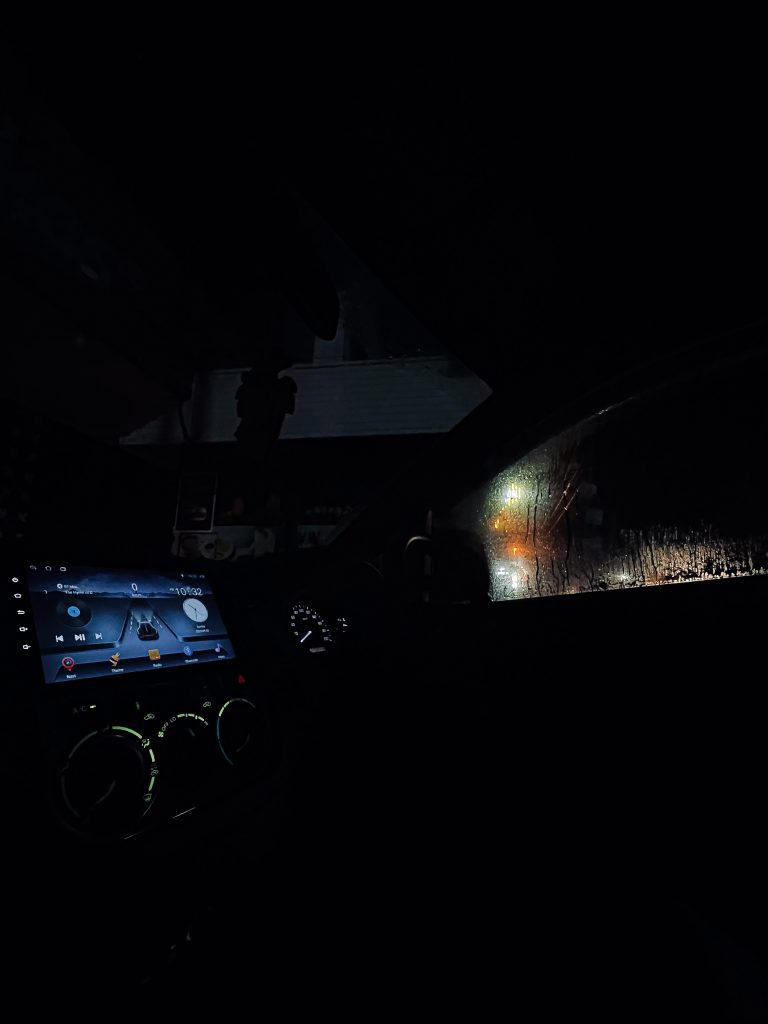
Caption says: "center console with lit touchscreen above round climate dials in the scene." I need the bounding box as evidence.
[4,562,280,839]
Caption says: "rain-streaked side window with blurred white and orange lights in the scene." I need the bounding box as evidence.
[454,353,768,600]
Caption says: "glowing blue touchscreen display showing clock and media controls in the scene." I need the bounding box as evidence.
[28,565,234,683]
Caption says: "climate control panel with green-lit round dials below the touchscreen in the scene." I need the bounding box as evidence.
[41,670,281,838]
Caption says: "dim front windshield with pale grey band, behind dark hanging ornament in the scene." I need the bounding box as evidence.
[113,217,492,560]
